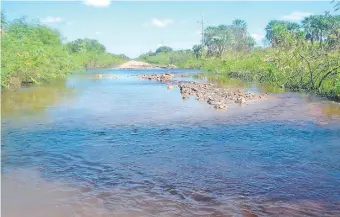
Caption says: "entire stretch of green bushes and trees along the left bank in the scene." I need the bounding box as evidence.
[1,15,126,88]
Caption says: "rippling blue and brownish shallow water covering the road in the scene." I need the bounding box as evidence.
[1,69,340,217]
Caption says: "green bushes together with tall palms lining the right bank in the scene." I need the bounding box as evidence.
[140,13,340,101]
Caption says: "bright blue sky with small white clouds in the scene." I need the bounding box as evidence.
[2,0,335,58]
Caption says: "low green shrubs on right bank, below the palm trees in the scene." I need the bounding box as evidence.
[139,47,340,102]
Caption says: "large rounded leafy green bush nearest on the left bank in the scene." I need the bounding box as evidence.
[1,19,73,87]
